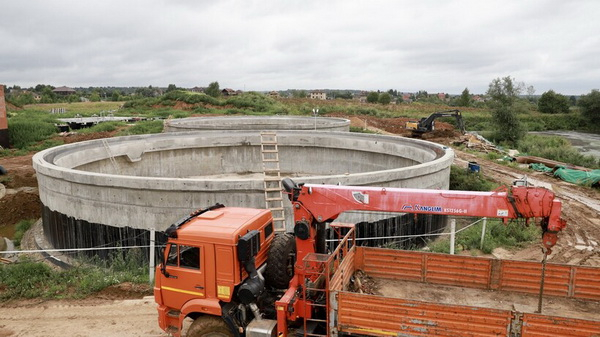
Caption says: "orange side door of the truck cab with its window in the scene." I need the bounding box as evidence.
[161,243,207,308]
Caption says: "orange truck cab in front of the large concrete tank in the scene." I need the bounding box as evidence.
[154,204,293,336]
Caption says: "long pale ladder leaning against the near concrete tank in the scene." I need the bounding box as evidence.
[260,131,285,232]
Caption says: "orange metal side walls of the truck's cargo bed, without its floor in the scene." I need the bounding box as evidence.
[331,247,600,337]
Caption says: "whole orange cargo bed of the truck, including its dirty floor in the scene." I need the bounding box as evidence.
[329,247,600,336]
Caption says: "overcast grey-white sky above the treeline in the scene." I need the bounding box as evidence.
[0,0,600,95]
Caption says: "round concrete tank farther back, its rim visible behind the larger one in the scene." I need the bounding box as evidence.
[164,116,350,132]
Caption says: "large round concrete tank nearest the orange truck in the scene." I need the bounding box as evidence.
[33,130,454,255]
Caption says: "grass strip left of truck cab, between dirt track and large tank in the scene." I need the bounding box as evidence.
[0,250,149,301]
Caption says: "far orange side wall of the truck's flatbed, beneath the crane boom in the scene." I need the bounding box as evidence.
[355,247,600,300]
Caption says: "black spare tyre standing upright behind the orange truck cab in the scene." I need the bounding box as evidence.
[265,233,296,289]
